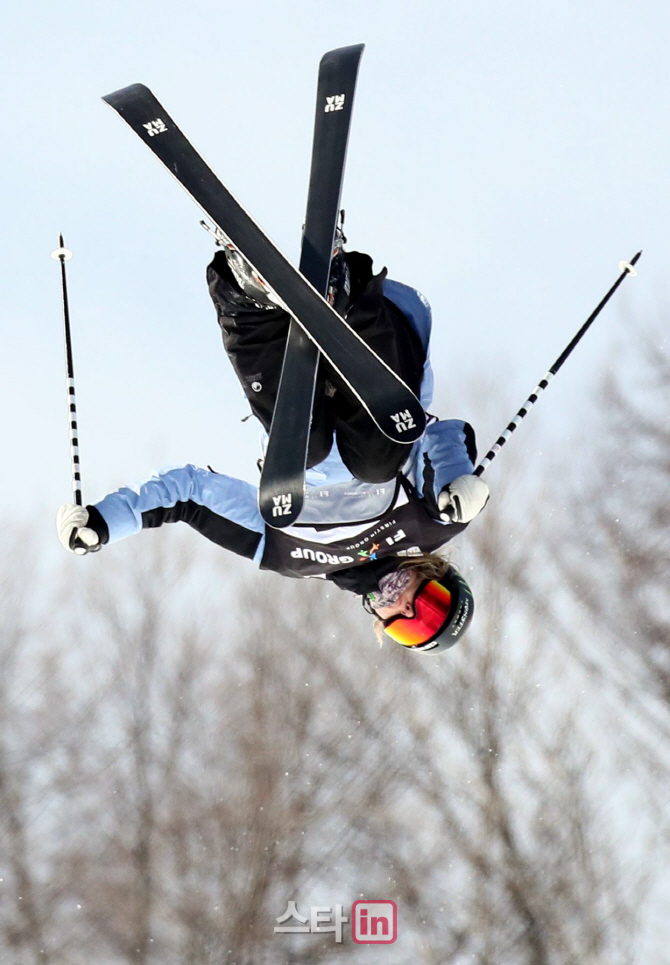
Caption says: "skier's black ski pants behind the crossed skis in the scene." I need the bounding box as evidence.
[207,251,425,483]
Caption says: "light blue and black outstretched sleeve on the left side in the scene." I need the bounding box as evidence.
[95,466,265,562]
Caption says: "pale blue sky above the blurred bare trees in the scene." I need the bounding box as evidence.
[0,0,670,527]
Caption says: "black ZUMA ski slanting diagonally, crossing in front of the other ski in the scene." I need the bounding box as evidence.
[103,84,425,443]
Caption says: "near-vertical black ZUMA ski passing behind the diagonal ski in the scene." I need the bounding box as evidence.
[258,44,365,527]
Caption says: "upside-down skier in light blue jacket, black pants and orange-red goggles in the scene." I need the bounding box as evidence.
[57,238,489,653]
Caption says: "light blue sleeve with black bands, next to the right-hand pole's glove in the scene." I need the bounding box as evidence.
[412,419,477,516]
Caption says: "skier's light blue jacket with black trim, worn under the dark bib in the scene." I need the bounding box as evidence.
[95,280,474,564]
